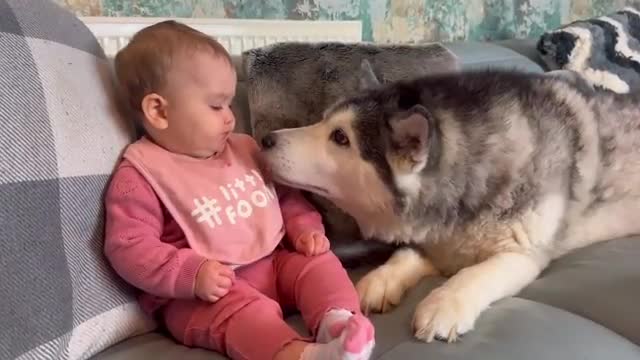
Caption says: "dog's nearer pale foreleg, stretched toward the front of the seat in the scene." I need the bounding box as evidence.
[413,252,543,342]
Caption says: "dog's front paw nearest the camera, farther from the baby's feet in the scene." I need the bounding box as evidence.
[413,288,478,342]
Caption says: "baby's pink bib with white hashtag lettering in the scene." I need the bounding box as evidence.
[124,134,285,266]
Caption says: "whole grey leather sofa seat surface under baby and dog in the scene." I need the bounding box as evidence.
[96,237,640,360]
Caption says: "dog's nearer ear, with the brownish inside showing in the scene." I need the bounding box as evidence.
[389,105,433,171]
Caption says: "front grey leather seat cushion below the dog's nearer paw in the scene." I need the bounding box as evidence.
[376,298,640,360]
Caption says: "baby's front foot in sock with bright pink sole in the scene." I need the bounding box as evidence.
[301,315,375,360]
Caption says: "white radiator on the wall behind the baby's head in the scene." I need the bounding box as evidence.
[80,16,362,56]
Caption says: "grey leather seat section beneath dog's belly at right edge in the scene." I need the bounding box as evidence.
[519,237,640,345]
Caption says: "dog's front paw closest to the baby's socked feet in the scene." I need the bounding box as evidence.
[356,265,407,313]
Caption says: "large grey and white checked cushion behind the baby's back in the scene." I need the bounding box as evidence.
[0,0,153,359]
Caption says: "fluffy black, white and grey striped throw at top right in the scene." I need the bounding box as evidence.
[537,7,640,93]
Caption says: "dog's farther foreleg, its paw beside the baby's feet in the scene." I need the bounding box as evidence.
[356,248,438,313]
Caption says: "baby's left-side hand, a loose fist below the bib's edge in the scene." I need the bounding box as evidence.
[195,260,235,302]
